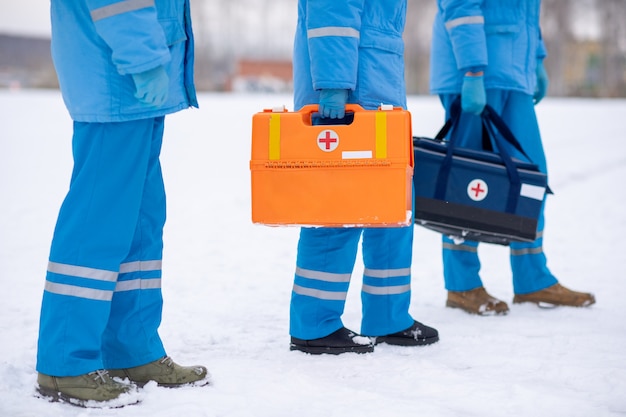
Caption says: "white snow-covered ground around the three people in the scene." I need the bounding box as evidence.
[0,91,626,417]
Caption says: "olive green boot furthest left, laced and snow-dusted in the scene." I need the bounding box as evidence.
[37,371,139,408]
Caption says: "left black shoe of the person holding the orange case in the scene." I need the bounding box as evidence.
[289,327,374,355]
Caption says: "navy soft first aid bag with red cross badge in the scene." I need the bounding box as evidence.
[413,101,550,245]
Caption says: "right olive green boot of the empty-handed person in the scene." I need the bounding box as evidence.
[109,356,210,388]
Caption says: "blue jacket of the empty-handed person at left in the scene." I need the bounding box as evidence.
[50,0,198,122]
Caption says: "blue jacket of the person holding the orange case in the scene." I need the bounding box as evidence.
[293,0,406,109]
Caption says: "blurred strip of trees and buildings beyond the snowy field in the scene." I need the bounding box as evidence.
[0,0,626,97]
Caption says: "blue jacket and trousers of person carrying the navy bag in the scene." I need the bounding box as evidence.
[430,0,557,294]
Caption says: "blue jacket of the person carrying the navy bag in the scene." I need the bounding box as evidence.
[430,0,546,94]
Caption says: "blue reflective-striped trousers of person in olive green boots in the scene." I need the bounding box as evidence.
[37,117,166,376]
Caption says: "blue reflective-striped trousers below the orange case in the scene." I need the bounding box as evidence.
[290,225,413,340]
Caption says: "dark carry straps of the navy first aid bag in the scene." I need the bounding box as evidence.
[434,97,532,213]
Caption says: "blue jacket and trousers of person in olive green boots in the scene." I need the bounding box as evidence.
[37,0,197,377]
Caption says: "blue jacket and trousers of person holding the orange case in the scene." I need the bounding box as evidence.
[290,0,413,340]
